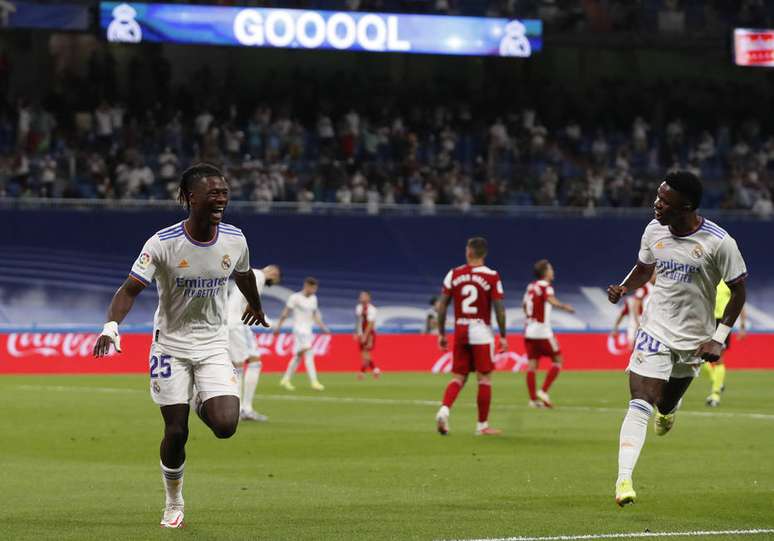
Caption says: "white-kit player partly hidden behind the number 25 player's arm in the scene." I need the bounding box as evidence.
[228,265,280,422]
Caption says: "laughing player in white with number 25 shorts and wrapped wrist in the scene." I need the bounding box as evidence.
[94,163,268,528]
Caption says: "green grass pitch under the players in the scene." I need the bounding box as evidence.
[0,372,774,540]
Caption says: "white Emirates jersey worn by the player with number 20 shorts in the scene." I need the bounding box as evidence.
[639,218,747,351]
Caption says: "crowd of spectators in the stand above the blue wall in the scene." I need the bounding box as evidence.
[0,89,774,215]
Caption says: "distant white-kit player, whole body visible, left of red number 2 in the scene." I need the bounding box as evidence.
[274,277,330,391]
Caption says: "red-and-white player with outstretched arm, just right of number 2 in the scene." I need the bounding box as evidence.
[523,259,575,408]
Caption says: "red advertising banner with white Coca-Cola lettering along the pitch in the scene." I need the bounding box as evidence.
[0,332,774,374]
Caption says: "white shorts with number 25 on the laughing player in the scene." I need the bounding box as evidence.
[149,343,239,406]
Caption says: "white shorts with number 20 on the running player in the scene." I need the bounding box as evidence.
[626,329,703,380]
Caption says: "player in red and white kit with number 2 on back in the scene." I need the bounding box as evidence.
[435,237,508,436]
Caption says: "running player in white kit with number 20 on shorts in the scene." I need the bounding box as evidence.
[607,171,747,507]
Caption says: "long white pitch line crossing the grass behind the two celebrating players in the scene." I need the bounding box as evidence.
[9,385,774,421]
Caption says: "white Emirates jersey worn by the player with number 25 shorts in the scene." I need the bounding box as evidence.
[130,222,250,358]
